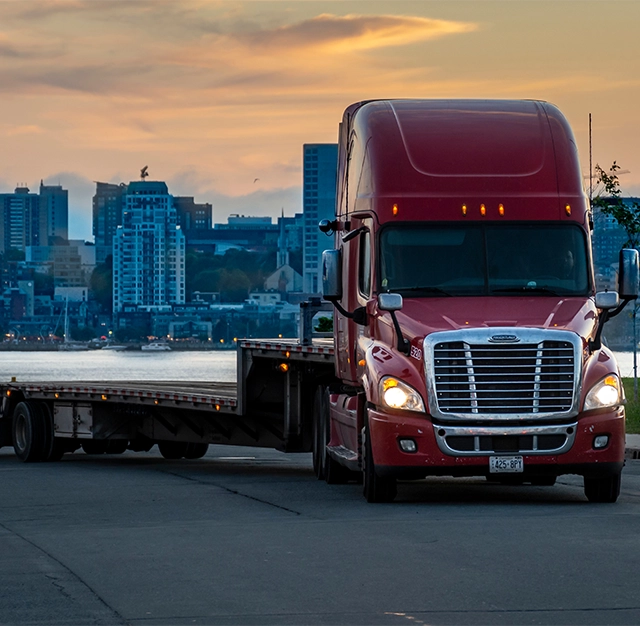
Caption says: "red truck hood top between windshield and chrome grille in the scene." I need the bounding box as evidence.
[396,297,598,340]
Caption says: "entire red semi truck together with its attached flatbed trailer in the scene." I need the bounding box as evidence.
[0,100,638,502]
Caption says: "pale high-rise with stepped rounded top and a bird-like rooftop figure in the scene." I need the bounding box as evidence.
[113,181,185,313]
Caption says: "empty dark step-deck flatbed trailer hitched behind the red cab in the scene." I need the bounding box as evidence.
[0,330,335,462]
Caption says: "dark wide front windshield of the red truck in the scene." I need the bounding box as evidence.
[378,223,589,297]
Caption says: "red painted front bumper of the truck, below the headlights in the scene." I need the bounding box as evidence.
[369,407,625,480]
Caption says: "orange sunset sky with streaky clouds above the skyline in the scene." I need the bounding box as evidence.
[0,0,640,240]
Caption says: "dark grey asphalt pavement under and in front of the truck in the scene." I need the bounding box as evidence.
[0,447,640,626]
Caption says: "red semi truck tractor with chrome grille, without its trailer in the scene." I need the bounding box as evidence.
[314,100,638,502]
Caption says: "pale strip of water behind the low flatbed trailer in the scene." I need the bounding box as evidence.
[0,350,236,382]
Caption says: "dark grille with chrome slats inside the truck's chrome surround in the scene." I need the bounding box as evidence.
[433,340,576,415]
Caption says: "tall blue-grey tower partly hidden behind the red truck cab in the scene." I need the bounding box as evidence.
[302,143,338,293]
